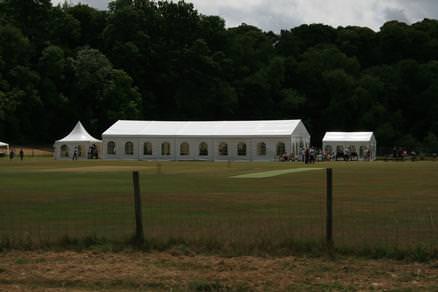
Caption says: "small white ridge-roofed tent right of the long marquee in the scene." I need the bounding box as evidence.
[322,132,377,160]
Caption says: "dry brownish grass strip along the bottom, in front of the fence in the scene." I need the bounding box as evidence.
[0,252,438,291]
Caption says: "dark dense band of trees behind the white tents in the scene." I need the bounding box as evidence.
[0,0,438,152]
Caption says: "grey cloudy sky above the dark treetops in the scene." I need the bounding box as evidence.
[52,0,438,32]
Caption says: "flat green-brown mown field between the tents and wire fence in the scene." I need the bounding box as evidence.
[0,158,438,255]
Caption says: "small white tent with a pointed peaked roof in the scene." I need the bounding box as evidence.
[54,122,102,159]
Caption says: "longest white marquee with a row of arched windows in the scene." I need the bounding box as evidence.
[102,120,310,161]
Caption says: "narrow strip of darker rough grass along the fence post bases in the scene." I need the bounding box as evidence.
[0,236,438,262]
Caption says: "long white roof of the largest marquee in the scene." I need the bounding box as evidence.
[102,120,302,137]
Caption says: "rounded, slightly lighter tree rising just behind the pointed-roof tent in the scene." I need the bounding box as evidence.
[69,48,141,131]
